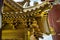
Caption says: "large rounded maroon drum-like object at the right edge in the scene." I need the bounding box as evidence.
[48,4,60,40]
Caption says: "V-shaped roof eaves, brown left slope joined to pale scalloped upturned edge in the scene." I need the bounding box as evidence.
[4,1,50,13]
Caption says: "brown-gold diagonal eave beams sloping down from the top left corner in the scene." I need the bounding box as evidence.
[4,0,23,11]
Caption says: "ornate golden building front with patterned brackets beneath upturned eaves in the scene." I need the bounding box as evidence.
[2,0,51,40]
